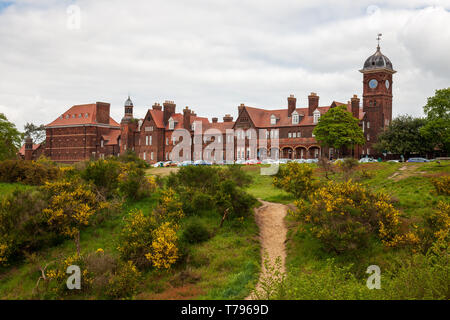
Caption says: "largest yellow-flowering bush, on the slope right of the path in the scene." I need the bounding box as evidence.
[296,180,418,253]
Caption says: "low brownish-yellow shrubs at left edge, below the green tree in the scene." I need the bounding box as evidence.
[0,160,60,185]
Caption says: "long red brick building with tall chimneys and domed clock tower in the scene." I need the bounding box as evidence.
[46,42,396,163]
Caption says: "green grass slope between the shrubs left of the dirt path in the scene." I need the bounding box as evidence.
[0,188,260,299]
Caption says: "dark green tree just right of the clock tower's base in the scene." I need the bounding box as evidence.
[374,115,430,157]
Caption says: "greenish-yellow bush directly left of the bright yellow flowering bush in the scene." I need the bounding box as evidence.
[117,210,157,268]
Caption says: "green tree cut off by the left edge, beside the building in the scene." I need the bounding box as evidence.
[0,113,22,161]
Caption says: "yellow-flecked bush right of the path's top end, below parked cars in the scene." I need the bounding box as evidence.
[273,162,317,198]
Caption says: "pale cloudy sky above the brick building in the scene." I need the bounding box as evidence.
[0,0,450,129]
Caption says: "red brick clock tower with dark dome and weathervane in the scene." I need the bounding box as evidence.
[360,34,396,155]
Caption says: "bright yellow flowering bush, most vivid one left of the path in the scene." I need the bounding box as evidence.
[145,222,179,269]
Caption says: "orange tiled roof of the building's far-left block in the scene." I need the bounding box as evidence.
[46,103,120,127]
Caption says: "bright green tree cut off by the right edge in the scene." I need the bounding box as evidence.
[420,88,450,154]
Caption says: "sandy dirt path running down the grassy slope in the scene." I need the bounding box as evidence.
[246,200,288,300]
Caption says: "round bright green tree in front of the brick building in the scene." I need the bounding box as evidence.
[313,106,364,157]
